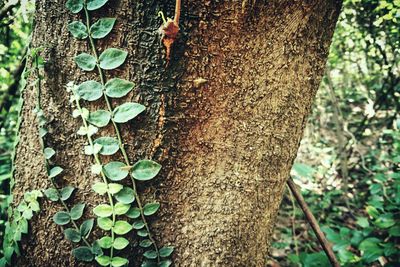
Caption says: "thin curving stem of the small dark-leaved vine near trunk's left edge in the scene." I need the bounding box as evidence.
[35,54,90,247]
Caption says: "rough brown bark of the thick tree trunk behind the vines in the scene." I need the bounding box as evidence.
[15,0,340,266]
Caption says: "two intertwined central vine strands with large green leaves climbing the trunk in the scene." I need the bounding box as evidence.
[66,0,173,267]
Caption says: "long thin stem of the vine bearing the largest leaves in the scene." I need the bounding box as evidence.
[84,6,160,263]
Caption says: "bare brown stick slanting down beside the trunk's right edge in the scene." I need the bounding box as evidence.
[287,177,340,267]
